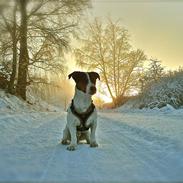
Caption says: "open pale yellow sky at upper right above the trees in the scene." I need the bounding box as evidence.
[83,0,183,69]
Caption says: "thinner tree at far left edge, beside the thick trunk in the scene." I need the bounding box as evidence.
[0,1,19,93]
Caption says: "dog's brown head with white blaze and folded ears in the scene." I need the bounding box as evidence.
[68,71,100,95]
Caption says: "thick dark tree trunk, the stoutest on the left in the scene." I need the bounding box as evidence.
[16,0,29,100]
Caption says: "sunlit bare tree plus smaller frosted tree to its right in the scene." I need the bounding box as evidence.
[75,18,167,106]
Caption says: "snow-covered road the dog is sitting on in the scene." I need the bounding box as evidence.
[0,111,183,182]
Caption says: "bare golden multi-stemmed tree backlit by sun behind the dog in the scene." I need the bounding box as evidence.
[75,19,146,105]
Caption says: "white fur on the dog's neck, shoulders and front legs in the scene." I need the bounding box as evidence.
[62,87,98,150]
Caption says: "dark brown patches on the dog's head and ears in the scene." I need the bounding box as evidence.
[68,71,100,94]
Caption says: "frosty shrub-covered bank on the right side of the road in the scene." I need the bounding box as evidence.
[121,71,183,110]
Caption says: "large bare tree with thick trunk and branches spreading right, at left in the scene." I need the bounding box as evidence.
[1,0,89,99]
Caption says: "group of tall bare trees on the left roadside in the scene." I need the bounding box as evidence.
[0,0,90,100]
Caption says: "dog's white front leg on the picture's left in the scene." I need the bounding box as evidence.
[67,124,77,151]
